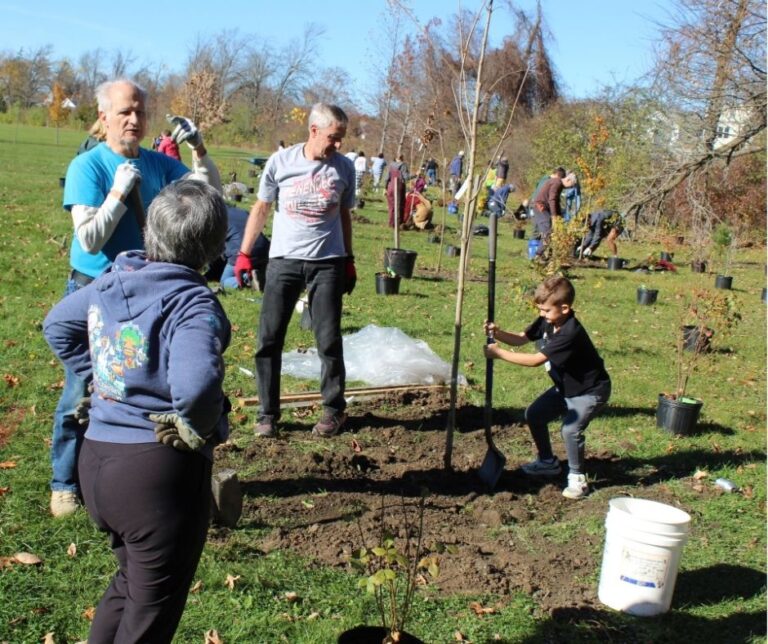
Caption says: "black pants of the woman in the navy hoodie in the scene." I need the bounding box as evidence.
[78,439,211,644]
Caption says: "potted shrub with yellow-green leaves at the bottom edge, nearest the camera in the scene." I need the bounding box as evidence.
[338,495,440,644]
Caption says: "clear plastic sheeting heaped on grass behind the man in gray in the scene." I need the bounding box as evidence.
[282,324,467,387]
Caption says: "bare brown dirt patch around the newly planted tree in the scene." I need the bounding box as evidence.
[217,393,672,612]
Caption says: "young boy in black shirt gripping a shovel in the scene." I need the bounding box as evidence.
[484,276,611,499]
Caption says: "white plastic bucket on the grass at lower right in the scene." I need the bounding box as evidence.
[597,497,691,616]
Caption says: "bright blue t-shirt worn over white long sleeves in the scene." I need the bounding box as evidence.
[64,143,189,277]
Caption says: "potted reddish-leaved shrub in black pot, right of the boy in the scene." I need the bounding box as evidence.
[656,289,741,435]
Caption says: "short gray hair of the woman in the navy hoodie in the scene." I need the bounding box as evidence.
[144,179,227,270]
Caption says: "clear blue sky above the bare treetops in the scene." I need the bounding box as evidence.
[0,0,673,98]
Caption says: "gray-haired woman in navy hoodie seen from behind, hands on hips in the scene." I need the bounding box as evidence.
[44,181,230,644]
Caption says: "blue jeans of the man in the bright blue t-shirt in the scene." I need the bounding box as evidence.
[51,279,88,494]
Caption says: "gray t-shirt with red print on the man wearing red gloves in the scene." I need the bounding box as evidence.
[258,143,355,260]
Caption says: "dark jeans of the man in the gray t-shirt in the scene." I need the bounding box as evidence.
[256,257,346,418]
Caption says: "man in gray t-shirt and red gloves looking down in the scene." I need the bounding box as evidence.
[235,103,357,438]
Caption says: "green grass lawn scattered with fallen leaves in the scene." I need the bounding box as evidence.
[0,125,766,644]
